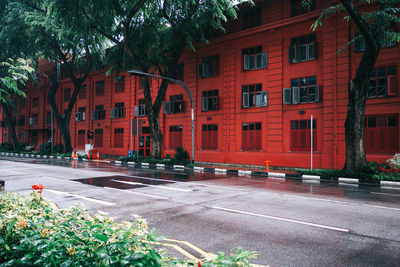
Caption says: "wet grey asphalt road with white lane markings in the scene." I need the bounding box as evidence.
[0,158,400,266]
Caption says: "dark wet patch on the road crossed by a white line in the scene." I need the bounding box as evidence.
[73,175,171,189]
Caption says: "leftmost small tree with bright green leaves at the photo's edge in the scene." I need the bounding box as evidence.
[0,58,34,149]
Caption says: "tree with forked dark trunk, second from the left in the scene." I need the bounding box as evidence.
[7,0,104,152]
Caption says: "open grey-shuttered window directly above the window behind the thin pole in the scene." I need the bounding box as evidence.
[283,76,319,104]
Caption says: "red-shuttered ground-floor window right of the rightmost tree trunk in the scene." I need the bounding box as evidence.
[365,115,399,153]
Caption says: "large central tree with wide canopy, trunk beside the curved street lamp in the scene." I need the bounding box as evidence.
[53,0,241,158]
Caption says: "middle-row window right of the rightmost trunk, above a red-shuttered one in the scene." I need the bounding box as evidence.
[368,66,397,98]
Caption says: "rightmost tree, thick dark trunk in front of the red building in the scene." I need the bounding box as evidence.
[303,0,400,171]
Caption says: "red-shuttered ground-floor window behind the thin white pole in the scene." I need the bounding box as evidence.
[290,120,317,151]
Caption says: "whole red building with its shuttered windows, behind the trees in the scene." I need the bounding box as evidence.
[1,0,400,168]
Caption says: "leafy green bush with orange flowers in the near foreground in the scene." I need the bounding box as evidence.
[0,191,256,266]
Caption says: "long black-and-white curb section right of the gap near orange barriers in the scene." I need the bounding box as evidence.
[114,161,400,188]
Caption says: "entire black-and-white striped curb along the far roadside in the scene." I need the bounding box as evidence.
[0,152,400,189]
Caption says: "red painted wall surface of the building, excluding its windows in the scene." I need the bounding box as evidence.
[1,0,400,168]
